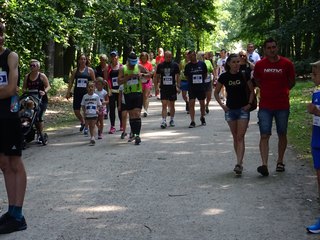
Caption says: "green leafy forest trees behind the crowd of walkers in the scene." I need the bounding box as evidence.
[0,0,320,80]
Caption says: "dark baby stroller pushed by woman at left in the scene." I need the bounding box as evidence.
[19,90,48,149]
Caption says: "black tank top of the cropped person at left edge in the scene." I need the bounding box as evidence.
[0,48,20,119]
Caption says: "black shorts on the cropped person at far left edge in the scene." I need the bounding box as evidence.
[0,118,23,156]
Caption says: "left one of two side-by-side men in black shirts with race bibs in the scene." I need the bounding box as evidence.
[157,51,180,128]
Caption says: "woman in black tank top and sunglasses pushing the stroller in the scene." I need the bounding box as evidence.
[22,59,51,143]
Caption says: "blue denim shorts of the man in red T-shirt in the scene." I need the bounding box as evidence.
[258,108,290,135]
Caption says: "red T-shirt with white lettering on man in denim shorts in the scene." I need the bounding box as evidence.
[254,56,295,110]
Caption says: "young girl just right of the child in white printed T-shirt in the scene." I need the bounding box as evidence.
[95,77,109,139]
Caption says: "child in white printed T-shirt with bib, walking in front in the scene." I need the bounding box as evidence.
[81,82,102,145]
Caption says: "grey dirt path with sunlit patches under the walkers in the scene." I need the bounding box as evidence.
[0,96,320,240]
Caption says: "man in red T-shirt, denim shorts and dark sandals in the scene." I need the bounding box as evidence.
[254,38,295,176]
